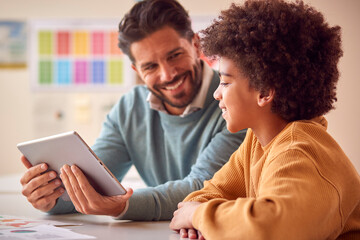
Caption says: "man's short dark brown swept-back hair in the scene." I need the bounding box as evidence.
[119,0,194,62]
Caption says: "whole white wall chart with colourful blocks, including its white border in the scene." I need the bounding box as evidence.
[30,19,135,91]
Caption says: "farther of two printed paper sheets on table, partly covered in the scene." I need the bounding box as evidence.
[0,215,82,230]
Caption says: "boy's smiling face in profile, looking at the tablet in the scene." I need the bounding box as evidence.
[214,57,259,132]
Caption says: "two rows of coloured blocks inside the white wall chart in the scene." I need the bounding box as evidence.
[37,29,124,87]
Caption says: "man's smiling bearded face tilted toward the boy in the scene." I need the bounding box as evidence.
[130,27,201,114]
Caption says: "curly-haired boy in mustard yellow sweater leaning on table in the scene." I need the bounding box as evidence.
[170,0,360,240]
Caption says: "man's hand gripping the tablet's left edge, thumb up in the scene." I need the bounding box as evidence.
[20,156,65,212]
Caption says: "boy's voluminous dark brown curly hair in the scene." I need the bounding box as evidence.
[200,0,343,121]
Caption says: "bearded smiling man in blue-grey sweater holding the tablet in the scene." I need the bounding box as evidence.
[21,0,245,220]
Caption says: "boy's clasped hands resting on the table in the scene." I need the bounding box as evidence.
[170,202,205,240]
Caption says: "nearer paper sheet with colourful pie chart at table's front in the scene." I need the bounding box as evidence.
[0,225,95,240]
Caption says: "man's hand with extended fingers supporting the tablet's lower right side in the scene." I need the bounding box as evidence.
[60,165,133,217]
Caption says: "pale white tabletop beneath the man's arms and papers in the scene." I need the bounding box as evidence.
[0,179,180,240]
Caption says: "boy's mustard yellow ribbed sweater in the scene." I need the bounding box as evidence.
[185,117,360,240]
